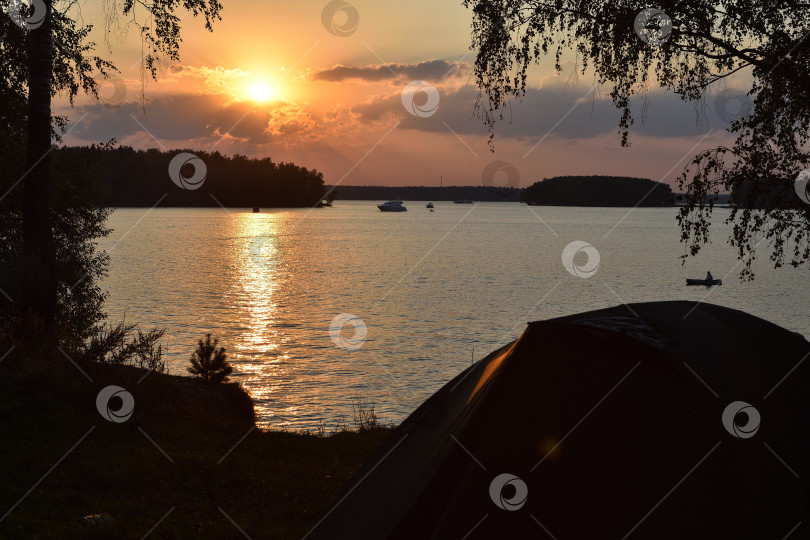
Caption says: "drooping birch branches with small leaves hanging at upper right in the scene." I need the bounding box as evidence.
[464,0,810,278]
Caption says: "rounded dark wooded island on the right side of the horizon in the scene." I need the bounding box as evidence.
[521,176,674,206]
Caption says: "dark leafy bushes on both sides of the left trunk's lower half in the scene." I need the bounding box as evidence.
[0,140,111,353]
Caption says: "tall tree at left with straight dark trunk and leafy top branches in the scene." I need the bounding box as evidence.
[13,0,222,326]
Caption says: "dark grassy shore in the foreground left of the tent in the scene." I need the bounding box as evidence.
[0,356,391,539]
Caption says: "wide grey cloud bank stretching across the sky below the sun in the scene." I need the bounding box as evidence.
[64,78,730,150]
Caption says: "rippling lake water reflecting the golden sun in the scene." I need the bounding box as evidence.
[102,201,810,430]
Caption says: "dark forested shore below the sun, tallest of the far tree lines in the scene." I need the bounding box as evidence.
[55,146,326,207]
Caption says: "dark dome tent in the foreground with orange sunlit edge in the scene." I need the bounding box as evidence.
[307,302,810,540]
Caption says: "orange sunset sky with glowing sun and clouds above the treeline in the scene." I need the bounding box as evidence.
[55,0,736,187]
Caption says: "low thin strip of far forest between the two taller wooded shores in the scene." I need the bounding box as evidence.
[328,186,522,202]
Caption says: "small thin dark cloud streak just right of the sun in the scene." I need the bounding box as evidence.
[310,60,470,82]
